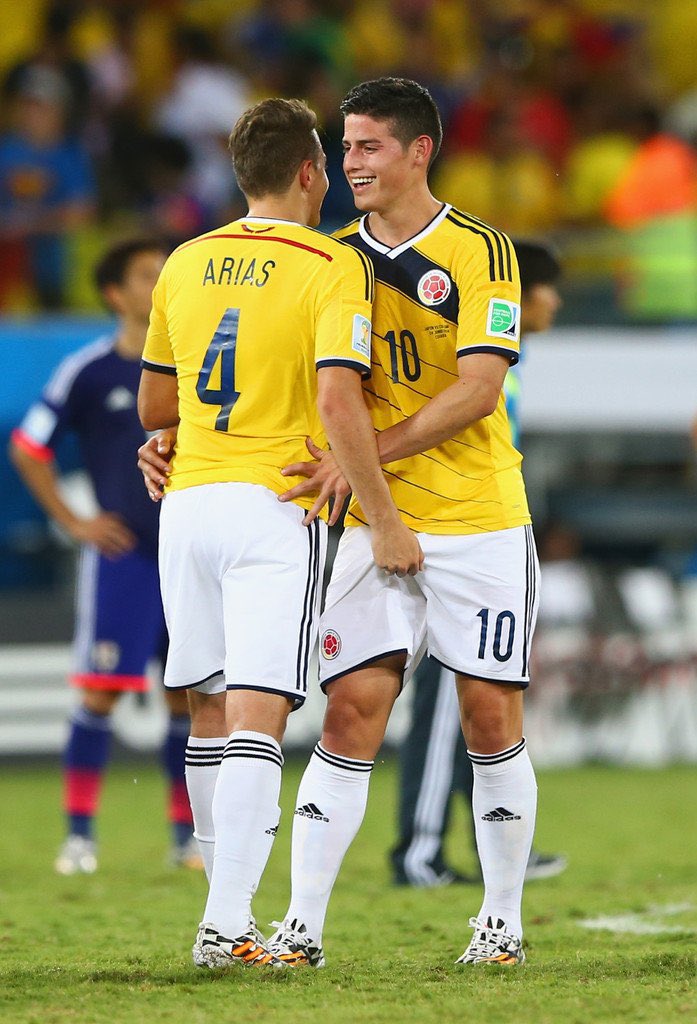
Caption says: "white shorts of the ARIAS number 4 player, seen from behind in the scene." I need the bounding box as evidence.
[160,483,326,707]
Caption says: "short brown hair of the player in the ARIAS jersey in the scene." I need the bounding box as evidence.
[229,99,321,199]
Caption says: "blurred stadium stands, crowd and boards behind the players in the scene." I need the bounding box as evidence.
[0,0,697,765]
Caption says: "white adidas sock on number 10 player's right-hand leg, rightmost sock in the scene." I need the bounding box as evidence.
[468,738,537,938]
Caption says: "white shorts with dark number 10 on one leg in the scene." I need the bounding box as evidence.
[319,526,539,688]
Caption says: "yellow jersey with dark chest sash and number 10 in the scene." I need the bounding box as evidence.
[336,204,530,534]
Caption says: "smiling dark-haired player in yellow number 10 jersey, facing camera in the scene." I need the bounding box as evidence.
[268,79,538,966]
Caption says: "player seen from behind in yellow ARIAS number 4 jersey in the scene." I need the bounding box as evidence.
[138,99,423,967]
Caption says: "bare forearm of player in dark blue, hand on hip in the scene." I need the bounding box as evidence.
[9,430,136,558]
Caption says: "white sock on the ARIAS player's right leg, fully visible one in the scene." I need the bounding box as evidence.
[204,731,284,938]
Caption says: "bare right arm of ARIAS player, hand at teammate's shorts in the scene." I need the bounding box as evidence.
[317,367,424,575]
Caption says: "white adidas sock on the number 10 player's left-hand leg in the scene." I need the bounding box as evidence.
[286,743,374,943]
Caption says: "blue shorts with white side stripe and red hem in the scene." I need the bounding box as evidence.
[71,547,167,690]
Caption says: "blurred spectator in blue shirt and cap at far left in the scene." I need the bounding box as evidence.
[0,63,95,309]
